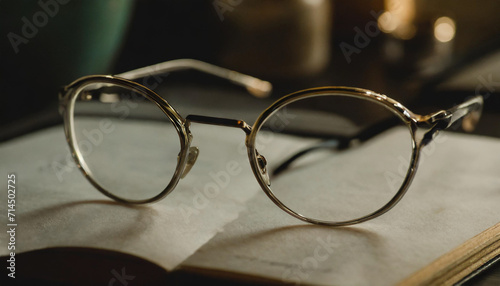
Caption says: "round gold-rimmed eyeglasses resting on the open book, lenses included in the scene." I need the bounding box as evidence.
[59,59,483,226]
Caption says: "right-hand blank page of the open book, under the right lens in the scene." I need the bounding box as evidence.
[183,128,500,285]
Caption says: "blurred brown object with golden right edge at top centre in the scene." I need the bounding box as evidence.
[215,0,333,78]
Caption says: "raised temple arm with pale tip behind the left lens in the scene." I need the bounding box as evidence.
[116,59,272,97]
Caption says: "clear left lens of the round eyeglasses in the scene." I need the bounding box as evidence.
[69,80,181,201]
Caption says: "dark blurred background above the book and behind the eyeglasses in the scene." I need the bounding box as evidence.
[0,0,500,141]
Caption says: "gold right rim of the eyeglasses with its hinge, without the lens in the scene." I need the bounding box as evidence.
[246,87,483,226]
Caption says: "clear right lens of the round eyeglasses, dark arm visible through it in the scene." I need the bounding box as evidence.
[254,92,413,223]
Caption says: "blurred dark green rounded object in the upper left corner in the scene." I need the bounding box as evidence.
[0,0,133,83]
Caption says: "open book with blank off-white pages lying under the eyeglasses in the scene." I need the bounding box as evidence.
[0,125,500,285]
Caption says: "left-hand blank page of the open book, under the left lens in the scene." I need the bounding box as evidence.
[0,124,259,270]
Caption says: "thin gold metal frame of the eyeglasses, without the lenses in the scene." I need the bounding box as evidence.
[59,59,483,226]
